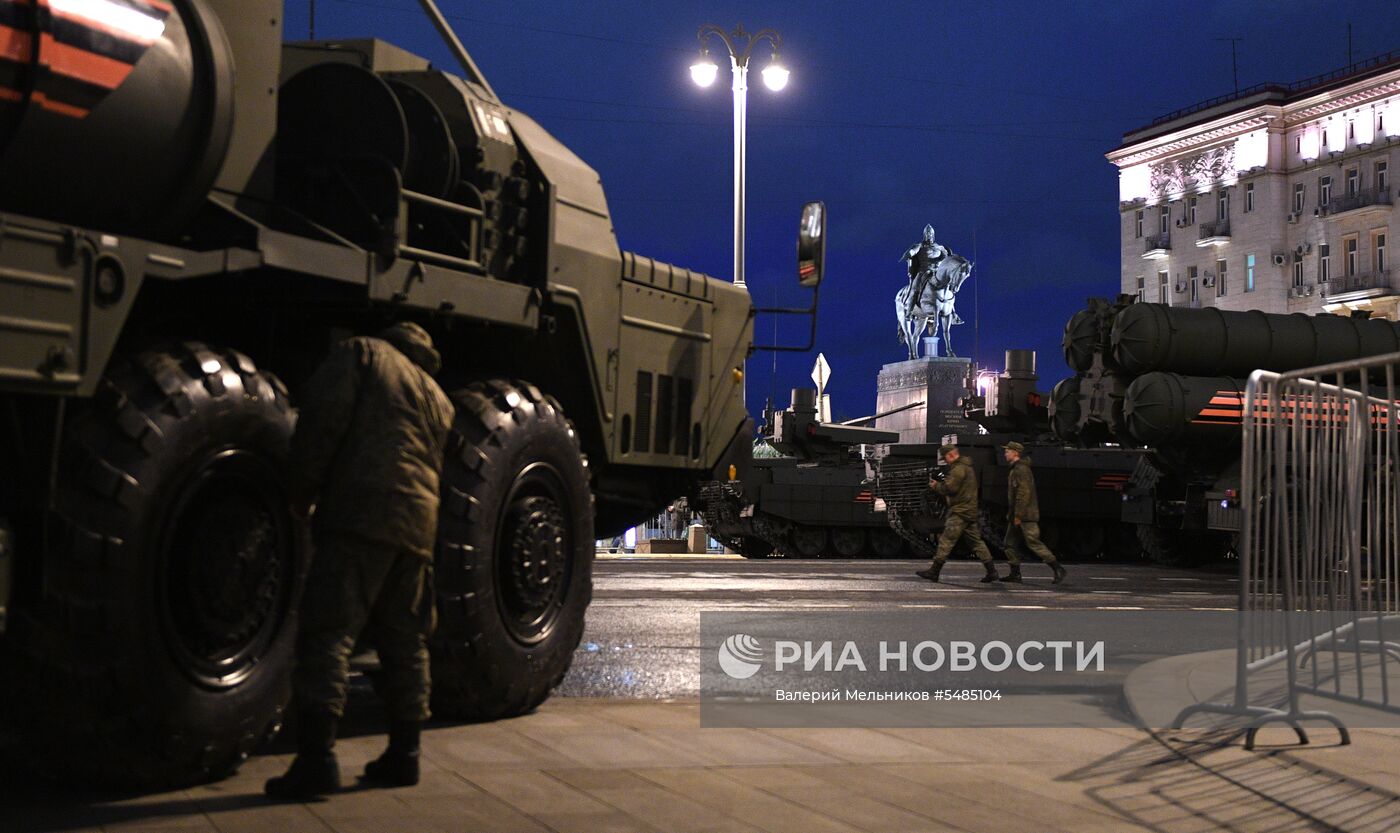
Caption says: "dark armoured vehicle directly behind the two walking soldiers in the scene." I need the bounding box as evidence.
[872,350,1142,559]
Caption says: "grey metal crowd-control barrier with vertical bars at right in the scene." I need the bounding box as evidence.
[1173,354,1400,749]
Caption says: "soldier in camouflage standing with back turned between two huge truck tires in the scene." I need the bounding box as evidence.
[267,323,454,798]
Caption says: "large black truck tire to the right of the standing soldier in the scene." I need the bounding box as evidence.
[430,381,594,720]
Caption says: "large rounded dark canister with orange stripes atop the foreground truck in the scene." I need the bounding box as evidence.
[0,0,234,235]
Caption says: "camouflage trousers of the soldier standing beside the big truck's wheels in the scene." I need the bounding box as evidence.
[293,535,435,721]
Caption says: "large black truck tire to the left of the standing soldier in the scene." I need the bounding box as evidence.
[0,343,308,788]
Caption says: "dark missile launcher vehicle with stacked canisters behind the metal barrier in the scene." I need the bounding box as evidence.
[1051,295,1400,563]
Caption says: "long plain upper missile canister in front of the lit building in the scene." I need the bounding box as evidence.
[1112,304,1400,377]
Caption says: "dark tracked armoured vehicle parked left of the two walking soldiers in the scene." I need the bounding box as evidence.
[697,388,907,559]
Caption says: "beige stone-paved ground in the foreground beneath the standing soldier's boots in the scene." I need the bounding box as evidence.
[0,697,1400,833]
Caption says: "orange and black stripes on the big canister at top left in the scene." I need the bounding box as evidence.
[0,0,172,118]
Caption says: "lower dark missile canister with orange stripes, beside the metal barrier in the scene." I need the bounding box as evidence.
[1123,372,1245,445]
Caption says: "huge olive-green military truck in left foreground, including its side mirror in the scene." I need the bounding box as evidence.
[0,0,825,785]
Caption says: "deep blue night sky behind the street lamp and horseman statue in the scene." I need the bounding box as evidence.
[287,0,1400,419]
